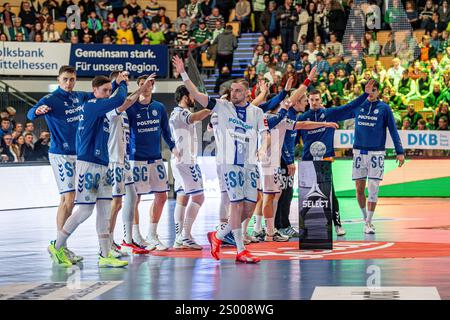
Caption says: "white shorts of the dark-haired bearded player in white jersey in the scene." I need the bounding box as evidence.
[170,159,203,195]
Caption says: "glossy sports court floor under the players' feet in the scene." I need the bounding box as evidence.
[0,198,450,300]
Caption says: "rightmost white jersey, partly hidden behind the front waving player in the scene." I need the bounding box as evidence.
[262,113,296,167]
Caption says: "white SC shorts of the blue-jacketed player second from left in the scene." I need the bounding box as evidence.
[75,160,114,204]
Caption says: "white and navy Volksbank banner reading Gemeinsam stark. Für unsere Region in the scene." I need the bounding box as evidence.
[0,42,169,77]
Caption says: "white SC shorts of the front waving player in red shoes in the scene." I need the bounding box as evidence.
[221,165,258,203]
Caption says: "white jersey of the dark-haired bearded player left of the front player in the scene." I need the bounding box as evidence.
[169,106,198,164]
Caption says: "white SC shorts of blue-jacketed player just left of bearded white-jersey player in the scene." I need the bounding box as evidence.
[131,160,170,195]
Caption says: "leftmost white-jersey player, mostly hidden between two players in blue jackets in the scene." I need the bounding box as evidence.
[106,73,156,258]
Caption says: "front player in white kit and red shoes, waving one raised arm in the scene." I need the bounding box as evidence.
[173,56,270,263]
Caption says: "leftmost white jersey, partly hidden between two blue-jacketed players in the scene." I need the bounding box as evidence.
[106,110,130,164]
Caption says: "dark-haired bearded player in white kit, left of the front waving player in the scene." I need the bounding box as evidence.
[169,86,210,250]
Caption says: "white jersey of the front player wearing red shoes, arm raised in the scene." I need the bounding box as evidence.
[208,98,268,165]
